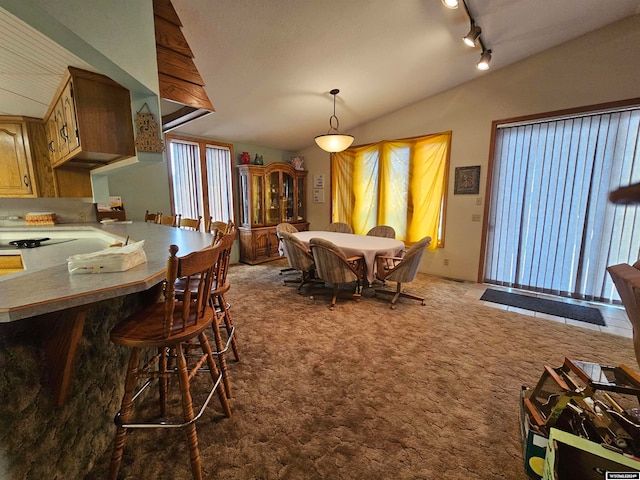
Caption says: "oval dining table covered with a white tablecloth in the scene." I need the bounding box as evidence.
[293,230,404,285]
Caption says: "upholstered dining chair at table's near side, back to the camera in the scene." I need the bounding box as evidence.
[309,238,365,310]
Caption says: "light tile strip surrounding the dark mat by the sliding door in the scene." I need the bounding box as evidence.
[465,283,632,338]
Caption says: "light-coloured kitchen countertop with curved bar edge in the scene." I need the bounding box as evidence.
[0,222,211,323]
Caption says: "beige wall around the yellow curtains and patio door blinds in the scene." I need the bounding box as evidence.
[299,15,640,281]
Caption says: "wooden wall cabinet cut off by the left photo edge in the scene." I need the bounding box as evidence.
[0,116,55,197]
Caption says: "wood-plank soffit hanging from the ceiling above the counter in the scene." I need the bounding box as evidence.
[153,0,215,132]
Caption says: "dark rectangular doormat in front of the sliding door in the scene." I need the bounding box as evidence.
[480,288,606,327]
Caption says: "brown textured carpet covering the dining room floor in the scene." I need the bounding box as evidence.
[87,262,638,480]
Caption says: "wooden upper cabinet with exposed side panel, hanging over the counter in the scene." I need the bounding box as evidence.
[45,67,135,168]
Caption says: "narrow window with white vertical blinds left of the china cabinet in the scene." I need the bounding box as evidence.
[168,136,234,227]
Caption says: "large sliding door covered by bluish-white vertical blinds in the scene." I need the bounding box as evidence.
[484,106,640,302]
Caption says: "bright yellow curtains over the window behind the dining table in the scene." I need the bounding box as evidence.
[331,132,451,250]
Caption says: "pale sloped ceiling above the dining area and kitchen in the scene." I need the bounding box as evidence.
[0,0,640,151]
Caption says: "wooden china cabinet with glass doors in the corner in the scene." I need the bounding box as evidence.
[238,163,309,265]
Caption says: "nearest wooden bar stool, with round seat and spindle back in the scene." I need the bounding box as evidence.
[109,242,231,480]
